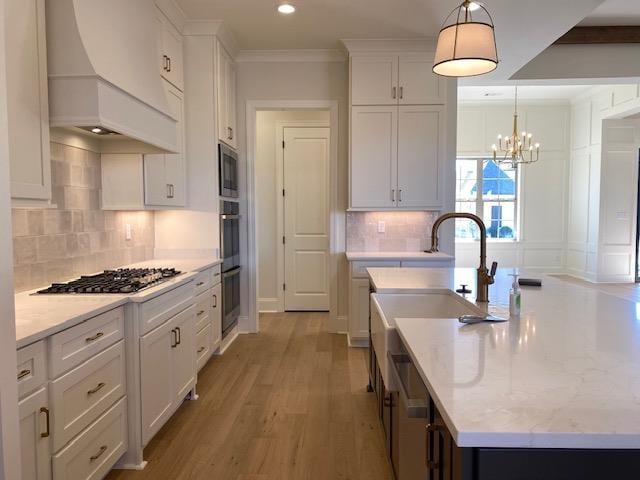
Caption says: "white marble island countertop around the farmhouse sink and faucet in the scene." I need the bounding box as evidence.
[370,268,640,449]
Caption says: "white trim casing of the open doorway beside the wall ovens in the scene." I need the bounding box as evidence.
[246,100,340,332]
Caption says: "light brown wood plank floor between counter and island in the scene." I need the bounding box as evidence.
[107,313,393,480]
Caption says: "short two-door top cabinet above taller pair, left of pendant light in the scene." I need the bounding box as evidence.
[351,53,445,105]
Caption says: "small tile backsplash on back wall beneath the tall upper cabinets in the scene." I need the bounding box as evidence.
[347,212,438,252]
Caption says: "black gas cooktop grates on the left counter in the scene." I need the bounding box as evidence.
[38,268,182,294]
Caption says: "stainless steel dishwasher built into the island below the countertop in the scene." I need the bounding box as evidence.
[387,352,432,480]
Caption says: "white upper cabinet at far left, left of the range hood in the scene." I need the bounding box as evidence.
[4,0,51,204]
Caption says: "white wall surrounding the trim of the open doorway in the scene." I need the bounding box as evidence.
[237,60,348,331]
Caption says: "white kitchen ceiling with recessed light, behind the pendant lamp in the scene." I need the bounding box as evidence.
[176,0,608,84]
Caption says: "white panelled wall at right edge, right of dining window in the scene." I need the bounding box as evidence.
[566,84,640,282]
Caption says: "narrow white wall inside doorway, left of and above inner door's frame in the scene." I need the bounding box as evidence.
[255,110,329,311]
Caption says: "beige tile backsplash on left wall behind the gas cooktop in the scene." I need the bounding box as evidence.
[12,143,154,292]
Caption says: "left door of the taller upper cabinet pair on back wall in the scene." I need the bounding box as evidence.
[350,106,398,208]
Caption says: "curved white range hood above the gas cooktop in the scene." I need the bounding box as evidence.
[46,0,177,152]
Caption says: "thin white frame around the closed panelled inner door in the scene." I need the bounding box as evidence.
[275,122,332,312]
